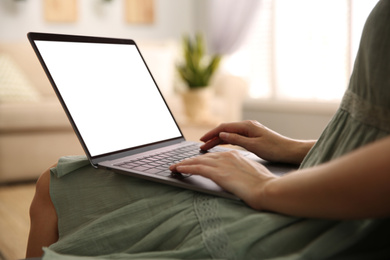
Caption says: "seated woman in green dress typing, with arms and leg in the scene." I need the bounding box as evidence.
[27,0,390,259]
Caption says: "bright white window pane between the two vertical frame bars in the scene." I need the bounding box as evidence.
[274,0,349,100]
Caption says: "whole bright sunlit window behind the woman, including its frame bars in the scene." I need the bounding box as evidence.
[225,0,378,102]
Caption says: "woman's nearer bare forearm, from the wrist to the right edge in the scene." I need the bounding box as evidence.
[260,138,390,219]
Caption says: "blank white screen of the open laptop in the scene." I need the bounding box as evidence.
[35,40,182,156]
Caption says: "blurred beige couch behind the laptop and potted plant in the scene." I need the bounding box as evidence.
[0,41,247,184]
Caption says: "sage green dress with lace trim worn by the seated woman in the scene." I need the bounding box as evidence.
[44,0,390,260]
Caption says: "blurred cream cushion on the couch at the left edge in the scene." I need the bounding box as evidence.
[0,53,40,103]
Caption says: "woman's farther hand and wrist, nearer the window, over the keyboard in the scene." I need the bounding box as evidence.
[200,120,315,164]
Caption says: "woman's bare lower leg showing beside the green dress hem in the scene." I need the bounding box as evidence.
[26,165,58,258]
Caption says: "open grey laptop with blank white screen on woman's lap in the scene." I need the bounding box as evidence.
[28,32,287,199]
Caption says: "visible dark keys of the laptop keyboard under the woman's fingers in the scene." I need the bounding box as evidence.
[114,144,224,177]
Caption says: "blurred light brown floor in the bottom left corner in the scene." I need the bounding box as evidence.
[0,182,35,260]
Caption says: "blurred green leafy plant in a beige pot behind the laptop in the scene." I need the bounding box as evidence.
[176,33,221,121]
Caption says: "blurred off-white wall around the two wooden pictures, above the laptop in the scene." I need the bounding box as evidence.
[0,0,196,42]
